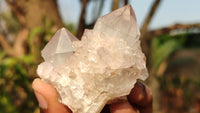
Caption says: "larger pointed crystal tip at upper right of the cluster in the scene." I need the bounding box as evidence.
[94,5,140,47]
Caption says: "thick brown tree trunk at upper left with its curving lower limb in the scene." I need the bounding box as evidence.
[0,0,63,59]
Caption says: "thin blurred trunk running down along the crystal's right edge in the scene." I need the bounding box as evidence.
[140,0,162,113]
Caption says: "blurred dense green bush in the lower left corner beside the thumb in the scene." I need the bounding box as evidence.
[0,52,37,113]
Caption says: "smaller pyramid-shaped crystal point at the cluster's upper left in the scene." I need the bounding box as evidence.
[42,28,78,64]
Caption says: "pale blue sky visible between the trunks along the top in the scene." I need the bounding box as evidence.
[58,0,200,29]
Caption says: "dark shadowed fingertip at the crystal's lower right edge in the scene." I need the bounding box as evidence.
[127,82,152,113]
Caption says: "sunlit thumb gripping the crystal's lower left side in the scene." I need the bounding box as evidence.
[32,78,71,113]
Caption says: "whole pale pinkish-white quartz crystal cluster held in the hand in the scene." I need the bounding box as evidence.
[37,5,148,113]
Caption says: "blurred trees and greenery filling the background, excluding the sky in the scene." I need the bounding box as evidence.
[0,0,200,113]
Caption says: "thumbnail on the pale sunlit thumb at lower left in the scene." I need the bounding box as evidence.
[35,91,47,109]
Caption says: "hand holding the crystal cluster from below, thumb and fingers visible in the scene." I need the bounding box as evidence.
[32,78,152,113]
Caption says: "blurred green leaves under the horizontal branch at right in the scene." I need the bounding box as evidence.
[151,33,200,70]
